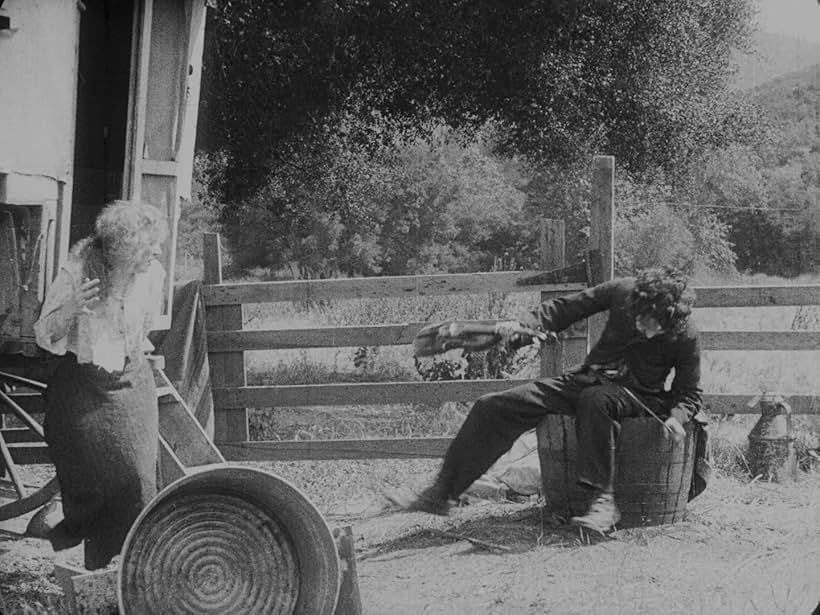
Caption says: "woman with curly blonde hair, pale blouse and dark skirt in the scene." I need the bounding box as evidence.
[30,201,168,569]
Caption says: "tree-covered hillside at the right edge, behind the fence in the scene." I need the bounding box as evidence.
[696,67,820,276]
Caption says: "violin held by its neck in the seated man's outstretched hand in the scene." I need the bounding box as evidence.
[413,320,557,357]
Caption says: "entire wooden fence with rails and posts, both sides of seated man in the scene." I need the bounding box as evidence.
[203,156,820,461]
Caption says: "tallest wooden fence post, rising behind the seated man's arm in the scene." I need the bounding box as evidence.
[588,156,615,345]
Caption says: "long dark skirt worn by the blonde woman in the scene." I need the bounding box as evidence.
[44,354,159,570]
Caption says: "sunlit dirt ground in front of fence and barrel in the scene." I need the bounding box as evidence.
[0,461,820,615]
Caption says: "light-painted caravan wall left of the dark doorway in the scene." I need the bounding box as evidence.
[0,0,81,353]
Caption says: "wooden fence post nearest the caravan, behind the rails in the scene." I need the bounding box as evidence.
[203,233,249,443]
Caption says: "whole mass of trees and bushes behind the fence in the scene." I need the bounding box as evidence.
[192,0,796,276]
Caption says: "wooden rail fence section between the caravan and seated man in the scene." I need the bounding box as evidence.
[203,235,586,460]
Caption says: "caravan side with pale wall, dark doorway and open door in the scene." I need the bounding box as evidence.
[0,0,206,335]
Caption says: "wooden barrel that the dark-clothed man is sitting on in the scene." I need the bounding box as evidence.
[536,415,695,527]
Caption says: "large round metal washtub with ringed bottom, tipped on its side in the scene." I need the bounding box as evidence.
[118,464,340,615]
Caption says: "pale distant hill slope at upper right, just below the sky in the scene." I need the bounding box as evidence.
[734,32,820,90]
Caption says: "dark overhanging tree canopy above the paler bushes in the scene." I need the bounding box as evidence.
[202,0,752,202]
